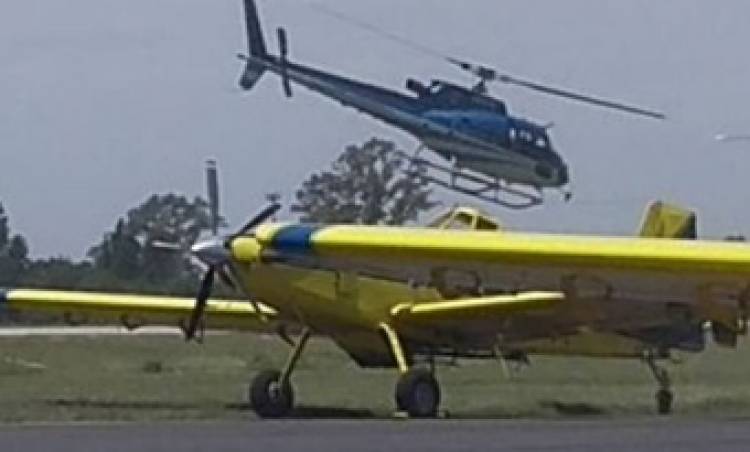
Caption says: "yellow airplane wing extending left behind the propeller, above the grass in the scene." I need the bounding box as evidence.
[0,289,277,332]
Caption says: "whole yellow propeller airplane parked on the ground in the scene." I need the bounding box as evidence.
[0,191,750,417]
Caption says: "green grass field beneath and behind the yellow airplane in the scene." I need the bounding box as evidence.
[0,334,750,422]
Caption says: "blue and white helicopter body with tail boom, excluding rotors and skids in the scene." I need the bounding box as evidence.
[252,56,569,188]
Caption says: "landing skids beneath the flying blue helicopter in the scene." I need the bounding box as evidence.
[397,151,544,210]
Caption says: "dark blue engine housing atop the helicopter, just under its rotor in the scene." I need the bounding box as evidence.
[406,79,508,115]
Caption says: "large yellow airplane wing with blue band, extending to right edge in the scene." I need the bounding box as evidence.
[250,221,750,336]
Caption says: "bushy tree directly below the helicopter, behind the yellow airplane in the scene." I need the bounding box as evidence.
[292,139,437,225]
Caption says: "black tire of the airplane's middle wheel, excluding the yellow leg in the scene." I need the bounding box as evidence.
[396,369,440,418]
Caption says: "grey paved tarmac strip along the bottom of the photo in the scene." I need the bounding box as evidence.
[0,418,750,452]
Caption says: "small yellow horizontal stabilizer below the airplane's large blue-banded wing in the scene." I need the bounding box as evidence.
[391,292,565,320]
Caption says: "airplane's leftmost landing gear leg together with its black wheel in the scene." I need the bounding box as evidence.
[249,328,312,418]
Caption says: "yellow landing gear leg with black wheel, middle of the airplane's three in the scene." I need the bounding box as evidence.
[380,324,440,418]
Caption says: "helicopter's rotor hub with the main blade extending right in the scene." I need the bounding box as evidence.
[446,57,666,119]
